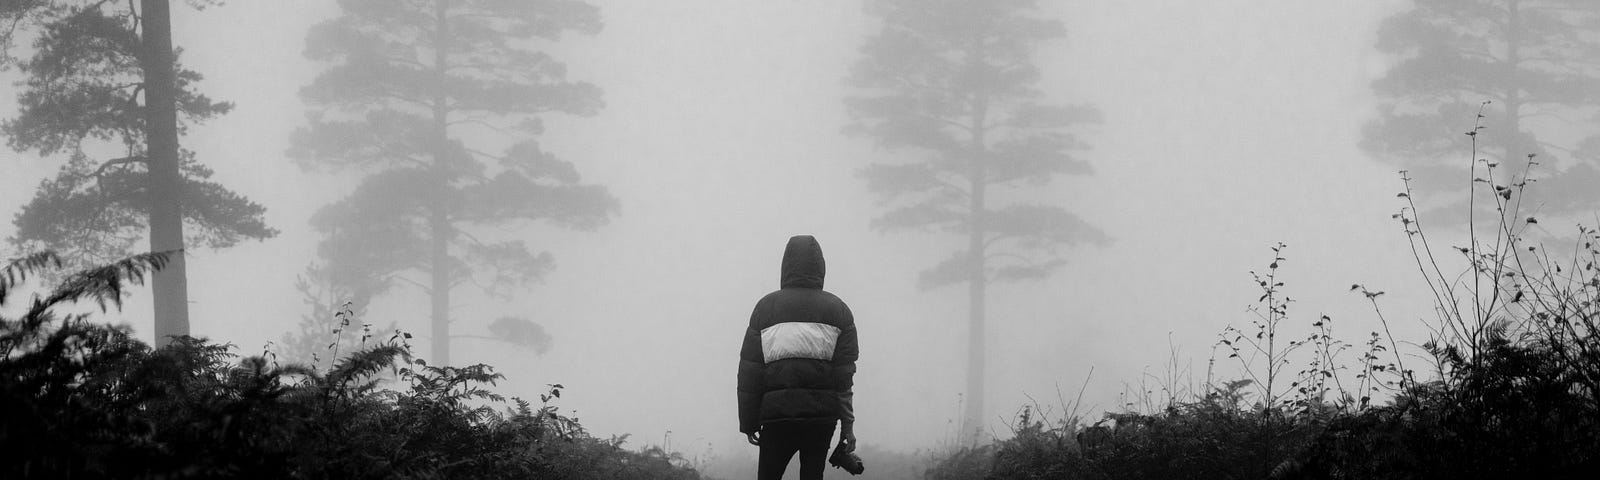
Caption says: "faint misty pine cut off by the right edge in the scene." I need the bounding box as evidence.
[1362,0,1600,213]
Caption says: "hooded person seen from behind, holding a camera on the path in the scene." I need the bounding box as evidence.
[738,235,861,480]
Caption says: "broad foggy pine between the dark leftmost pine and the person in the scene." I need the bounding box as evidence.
[291,0,618,365]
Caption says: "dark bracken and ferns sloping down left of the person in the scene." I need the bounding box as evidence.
[0,253,699,478]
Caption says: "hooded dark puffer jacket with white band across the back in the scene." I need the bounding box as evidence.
[739,235,861,434]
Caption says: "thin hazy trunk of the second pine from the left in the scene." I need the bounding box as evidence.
[427,0,454,366]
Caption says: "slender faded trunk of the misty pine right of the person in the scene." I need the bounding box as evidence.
[962,89,989,443]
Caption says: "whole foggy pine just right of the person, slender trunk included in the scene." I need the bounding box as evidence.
[846,0,1107,434]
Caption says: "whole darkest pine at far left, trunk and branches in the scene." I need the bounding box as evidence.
[0,0,277,342]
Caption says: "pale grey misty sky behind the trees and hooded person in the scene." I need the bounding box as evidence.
[0,0,1459,454]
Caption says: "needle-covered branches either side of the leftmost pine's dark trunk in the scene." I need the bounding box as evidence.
[0,0,277,266]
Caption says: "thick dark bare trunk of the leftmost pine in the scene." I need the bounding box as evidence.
[139,0,189,346]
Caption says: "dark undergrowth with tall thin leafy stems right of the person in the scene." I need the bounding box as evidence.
[928,114,1600,478]
